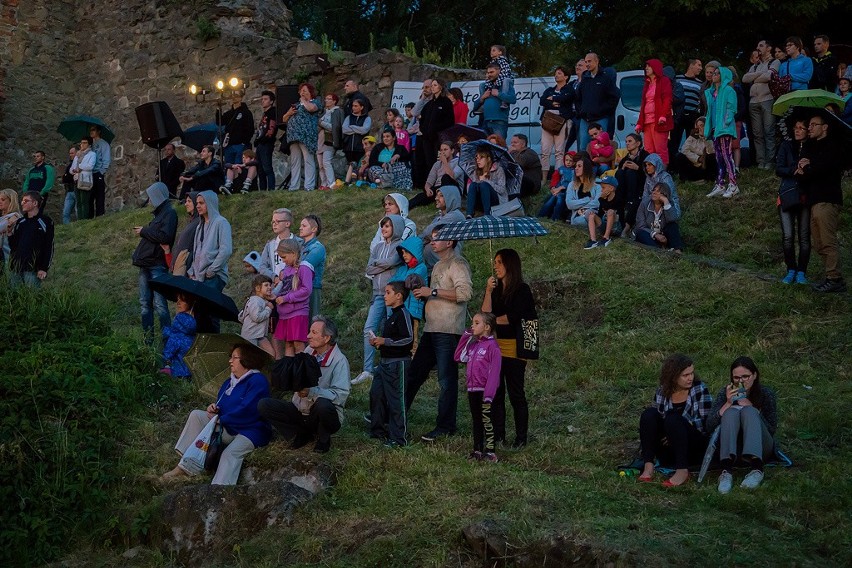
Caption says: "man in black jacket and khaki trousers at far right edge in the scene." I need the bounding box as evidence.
[794,114,846,292]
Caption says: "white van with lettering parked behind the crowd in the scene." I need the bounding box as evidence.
[391,69,645,164]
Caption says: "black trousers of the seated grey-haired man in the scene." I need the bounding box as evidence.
[257,398,340,446]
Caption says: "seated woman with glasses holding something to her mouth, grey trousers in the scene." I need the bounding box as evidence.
[707,357,778,494]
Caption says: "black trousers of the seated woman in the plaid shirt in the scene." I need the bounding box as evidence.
[639,408,708,469]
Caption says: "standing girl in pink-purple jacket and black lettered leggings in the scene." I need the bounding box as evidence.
[455,312,501,462]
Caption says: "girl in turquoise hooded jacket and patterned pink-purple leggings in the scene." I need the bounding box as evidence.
[704,66,740,198]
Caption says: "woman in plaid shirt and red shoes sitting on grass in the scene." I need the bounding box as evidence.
[639,354,713,487]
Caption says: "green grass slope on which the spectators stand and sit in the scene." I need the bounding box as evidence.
[51,172,852,566]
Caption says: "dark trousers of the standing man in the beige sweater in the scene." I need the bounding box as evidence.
[405,332,461,434]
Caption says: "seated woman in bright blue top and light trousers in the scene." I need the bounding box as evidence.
[160,345,272,485]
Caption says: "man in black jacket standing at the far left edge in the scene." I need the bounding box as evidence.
[9,191,53,288]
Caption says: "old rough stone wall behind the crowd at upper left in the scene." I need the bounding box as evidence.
[0,0,474,213]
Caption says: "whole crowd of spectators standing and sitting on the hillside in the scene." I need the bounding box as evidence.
[0,36,850,493]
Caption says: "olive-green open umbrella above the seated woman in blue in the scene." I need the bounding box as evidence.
[183,333,273,398]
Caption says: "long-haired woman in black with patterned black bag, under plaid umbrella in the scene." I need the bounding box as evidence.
[482,249,538,448]
